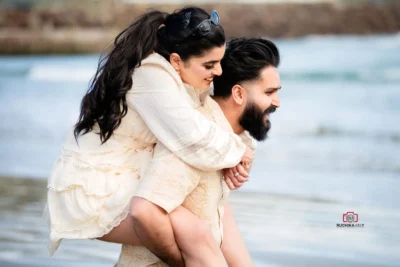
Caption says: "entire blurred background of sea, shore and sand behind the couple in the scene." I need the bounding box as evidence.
[0,0,400,267]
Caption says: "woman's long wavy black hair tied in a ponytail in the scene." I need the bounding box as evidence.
[74,7,225,143]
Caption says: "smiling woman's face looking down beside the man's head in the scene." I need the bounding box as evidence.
[171,45,225,90]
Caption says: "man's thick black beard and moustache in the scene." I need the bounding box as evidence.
[239,103,276,141]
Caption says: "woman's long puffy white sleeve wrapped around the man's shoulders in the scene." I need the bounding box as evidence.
[126,64,246,171]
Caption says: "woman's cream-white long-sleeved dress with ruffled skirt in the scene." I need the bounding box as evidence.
[48,53,245,254]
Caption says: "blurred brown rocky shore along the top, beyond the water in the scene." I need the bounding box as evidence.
[0,1,400,54]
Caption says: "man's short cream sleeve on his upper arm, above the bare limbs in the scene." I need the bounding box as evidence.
[135,143,200,213]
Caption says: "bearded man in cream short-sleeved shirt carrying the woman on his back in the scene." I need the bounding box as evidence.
[117,38,281,267]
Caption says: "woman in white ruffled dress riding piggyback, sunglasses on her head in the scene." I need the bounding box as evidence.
[48,8,253,267]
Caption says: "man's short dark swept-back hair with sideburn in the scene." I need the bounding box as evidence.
[214,38,280,98]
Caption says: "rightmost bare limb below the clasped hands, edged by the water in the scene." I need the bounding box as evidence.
[221,202,254,267]
